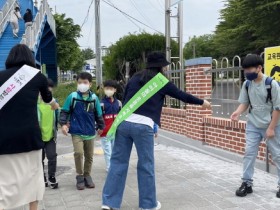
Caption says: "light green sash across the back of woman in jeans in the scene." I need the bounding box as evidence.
[107,73,169,140]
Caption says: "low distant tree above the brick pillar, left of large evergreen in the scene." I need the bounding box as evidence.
[184,34,219,59]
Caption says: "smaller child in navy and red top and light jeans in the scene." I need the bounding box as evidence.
[101,80,122,172]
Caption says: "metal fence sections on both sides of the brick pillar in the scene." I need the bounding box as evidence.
[164,56,247,120]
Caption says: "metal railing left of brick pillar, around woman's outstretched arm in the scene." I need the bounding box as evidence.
[164,62,186,109]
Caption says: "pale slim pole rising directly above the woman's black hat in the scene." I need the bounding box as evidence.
[165,0,171,65]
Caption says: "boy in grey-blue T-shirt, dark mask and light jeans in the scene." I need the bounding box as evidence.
[231,55,280,198]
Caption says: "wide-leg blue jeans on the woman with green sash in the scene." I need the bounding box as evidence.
[102,121,157,209]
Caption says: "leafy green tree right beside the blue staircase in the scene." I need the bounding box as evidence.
[54,14,84,71]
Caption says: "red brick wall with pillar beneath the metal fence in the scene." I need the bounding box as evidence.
[161,65,266,160]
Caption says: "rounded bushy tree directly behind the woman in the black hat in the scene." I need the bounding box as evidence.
[104,33,178,81]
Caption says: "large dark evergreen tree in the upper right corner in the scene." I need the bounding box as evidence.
[214,0,280,57]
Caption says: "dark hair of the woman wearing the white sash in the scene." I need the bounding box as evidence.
[5,44,36,69]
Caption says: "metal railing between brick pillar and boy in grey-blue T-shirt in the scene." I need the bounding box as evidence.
[209,56,247,120]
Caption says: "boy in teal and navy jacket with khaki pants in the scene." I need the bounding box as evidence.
[60,72,104,190]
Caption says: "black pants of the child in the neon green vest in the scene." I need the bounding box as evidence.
[42,139,57,177]
